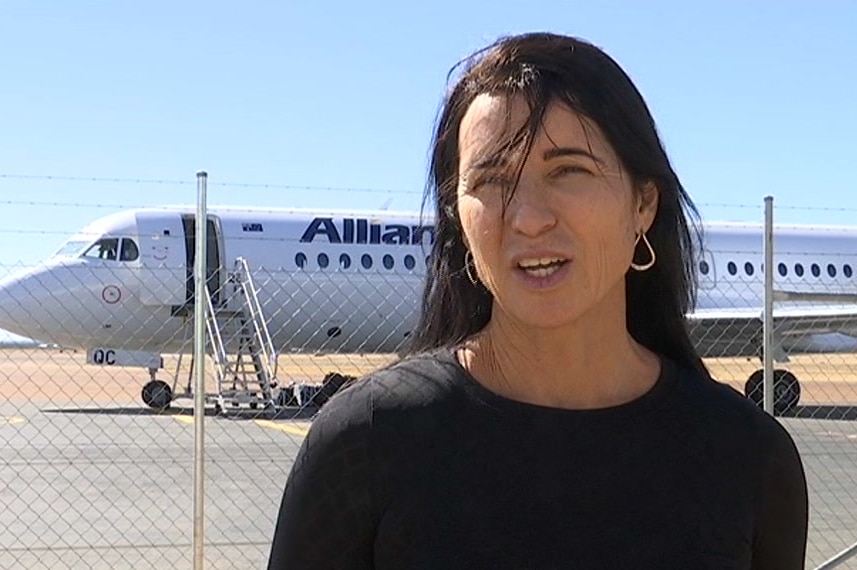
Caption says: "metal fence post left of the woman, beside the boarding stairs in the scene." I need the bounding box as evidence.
[193,171,208,570]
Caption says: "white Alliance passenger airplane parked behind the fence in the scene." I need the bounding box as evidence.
[0,206,857,414]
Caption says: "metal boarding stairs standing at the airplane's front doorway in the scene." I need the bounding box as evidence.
[205,257,277,413]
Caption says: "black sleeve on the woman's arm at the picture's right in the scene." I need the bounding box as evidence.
[753,421,809,570]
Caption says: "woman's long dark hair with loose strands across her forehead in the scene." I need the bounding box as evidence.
[405,33,706,372]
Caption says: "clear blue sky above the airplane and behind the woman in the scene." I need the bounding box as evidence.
[0,0,857,275]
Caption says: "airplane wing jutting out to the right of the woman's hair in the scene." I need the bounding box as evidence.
[688,302,857,357]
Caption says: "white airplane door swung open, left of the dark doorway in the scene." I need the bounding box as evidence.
[137,212,186,306]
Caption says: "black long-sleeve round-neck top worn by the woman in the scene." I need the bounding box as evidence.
[268,350,807,570]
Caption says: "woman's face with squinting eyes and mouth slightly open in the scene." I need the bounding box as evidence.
[457,94,657,328]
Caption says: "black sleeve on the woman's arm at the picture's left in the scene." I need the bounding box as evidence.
[268,385,375,570]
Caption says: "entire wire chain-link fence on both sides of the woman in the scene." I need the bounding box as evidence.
[0,180,857,569]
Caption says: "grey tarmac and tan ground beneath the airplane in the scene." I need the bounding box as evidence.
[0,350,857,570]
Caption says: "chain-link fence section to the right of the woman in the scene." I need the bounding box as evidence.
[691,215,857,568]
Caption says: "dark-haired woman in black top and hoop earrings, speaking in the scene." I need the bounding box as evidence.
[269,34,807,570]
